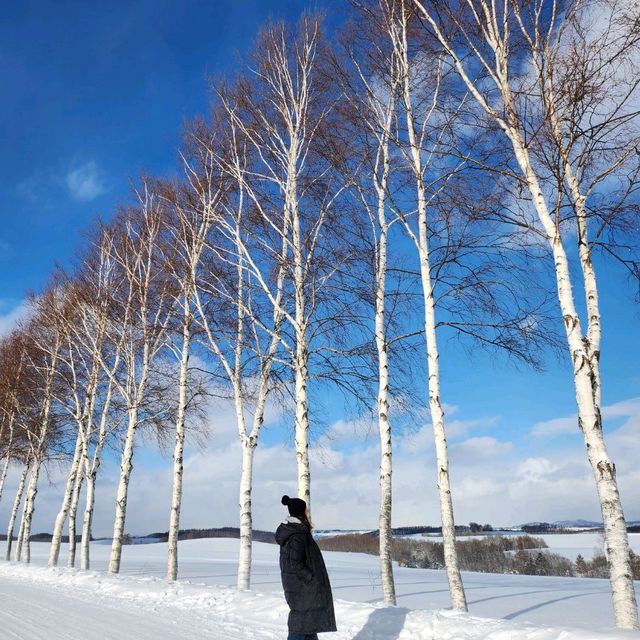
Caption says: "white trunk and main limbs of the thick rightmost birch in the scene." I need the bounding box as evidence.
[414,0,640,629]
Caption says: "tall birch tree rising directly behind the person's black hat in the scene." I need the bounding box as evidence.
[218,16,350,507]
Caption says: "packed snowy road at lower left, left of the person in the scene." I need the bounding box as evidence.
[0,564,282,640]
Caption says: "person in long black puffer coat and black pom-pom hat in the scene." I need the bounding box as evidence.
[276,496,337,640]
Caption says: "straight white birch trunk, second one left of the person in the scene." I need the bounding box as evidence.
[167,308,191,580]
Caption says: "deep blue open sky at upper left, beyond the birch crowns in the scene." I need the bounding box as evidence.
[0,0,340,300]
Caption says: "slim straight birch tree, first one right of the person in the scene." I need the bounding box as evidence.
[336,6,399,605]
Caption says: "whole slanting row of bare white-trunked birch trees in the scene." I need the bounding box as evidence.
[0,0,640,628]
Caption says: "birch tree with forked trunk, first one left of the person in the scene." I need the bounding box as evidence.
[182,111,288,589]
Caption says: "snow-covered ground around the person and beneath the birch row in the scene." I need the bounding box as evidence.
[0,539,640,640]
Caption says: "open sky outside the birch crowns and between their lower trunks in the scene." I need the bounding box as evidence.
[0,0,640,533]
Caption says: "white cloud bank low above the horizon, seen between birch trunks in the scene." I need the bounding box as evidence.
[0,399,640,535]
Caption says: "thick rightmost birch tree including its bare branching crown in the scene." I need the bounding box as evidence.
[413,0,639,628]
